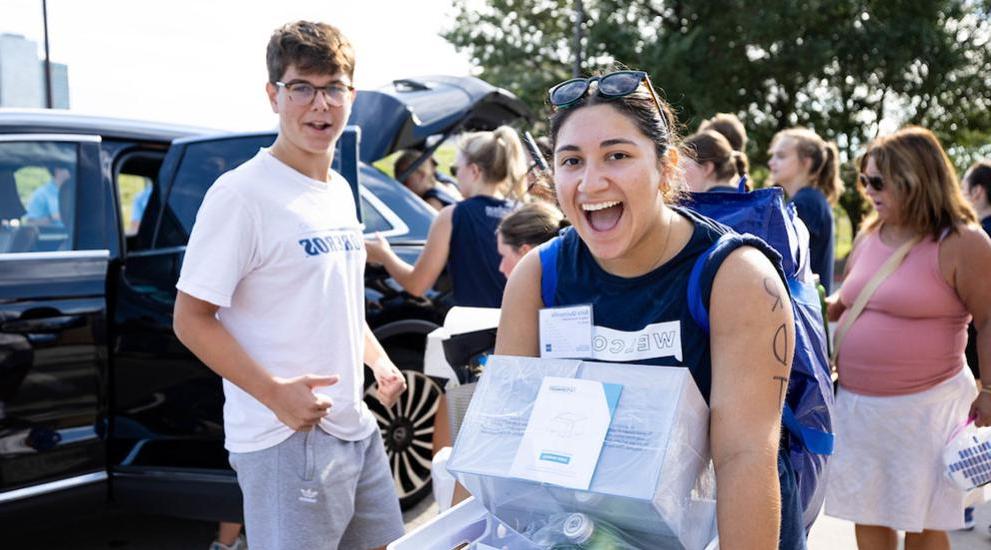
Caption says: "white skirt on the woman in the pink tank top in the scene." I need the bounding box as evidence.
[825,367,977,533]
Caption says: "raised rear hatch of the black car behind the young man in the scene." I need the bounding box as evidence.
[348,75,531,162]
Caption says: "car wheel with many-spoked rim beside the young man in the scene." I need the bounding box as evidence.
[365,348,443,511]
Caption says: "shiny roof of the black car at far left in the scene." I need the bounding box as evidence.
[0,108,215,143]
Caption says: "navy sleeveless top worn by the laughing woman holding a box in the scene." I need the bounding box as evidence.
[544,206,806,550]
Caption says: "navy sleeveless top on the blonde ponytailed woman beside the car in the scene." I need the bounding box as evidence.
[447,196,516,307]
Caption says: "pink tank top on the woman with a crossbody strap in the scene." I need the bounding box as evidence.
[837,231,970,396]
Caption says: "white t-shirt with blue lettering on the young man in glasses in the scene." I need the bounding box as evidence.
[176,149,377,452]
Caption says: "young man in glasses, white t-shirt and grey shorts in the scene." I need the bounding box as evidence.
[174,21,405,550]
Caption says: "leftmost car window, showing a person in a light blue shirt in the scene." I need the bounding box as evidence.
[0,141,79,253]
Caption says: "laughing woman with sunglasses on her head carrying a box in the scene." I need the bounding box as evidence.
[496,71,805,550]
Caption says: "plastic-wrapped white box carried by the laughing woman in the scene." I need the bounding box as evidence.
[448,356,716,550]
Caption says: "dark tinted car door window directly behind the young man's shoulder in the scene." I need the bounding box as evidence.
[156,135,275,247]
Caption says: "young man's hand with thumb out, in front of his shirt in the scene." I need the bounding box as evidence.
[264,374,340,432]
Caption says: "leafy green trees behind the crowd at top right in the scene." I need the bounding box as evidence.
[444,0,991,250]
